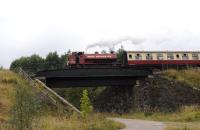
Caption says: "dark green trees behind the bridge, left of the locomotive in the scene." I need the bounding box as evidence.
[10,52,68,73]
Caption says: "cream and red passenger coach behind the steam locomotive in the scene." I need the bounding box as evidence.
[127,51,200,66]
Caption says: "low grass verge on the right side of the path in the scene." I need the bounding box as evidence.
[108,106,200,130]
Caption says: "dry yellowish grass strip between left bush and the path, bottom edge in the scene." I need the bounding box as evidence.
[33,114,124,130]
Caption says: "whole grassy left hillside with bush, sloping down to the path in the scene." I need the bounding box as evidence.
[0,70,123,130]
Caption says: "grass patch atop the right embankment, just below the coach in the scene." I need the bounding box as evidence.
[164,69,200,89]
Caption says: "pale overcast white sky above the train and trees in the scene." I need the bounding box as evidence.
[0,0,200,68]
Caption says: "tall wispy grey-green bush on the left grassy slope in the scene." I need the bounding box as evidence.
[11,85,40,130]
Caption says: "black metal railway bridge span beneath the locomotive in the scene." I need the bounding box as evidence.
[36,68,152,88]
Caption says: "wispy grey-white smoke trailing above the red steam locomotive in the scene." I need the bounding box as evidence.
[86,37,144,51]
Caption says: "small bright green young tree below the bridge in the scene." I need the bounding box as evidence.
[80,89,93,115]
